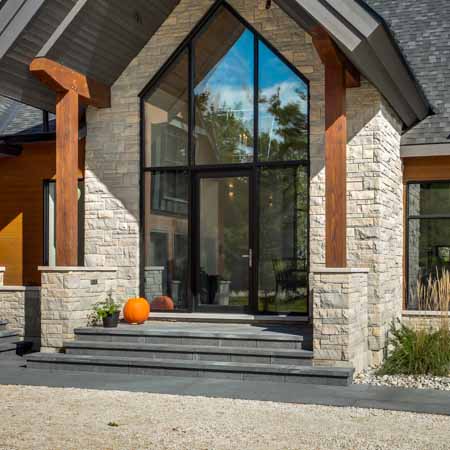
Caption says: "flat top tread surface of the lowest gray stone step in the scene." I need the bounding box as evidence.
[27,353,353,379]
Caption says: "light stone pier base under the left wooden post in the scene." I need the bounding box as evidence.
[39,267,117,352]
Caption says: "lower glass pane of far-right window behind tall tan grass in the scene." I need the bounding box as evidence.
[408,219,450,310]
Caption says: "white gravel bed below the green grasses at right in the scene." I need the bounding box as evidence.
[353,369,450,390]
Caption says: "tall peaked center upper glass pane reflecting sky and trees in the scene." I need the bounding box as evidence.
[194,8,254,164]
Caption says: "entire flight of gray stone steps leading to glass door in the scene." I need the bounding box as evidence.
[27,322,353,385]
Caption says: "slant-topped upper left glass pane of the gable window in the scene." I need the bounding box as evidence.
[144,50,189,167]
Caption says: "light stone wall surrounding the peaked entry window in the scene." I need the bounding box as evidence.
[85,0,324,297]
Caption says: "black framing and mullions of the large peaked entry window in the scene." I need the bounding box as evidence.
[139,0,311,316]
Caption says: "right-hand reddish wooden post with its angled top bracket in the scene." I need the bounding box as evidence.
[311,27,360,267]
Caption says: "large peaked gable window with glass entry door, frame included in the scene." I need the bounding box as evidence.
[141,1,309,314]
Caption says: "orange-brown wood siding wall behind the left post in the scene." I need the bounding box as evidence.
[0,142,84,285]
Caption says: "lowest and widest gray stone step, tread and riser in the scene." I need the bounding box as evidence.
[27,353,353,386]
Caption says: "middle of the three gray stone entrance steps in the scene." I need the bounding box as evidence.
[65,341,313,365]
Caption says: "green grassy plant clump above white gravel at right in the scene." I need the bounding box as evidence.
[379,324,450,376]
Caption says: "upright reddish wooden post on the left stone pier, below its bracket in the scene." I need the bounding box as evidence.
[56,90,79,266]
